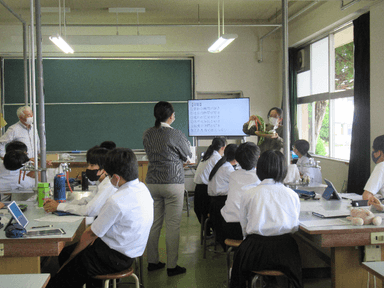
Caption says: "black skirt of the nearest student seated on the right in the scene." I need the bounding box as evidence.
[230,234,303,288]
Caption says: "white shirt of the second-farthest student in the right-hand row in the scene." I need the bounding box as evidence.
[208,162,235,196]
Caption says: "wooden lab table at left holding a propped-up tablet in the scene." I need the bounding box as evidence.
[0,202,85,274]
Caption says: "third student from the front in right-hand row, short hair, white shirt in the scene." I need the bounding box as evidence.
[221,142,260,240]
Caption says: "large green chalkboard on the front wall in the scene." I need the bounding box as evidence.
[2,57,195,152]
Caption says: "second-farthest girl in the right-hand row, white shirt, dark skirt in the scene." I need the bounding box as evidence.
[208,144,237,250]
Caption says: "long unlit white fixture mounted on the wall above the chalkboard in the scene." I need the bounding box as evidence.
[67,35,166,45]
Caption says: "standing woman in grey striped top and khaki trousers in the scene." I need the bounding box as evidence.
[143,101,192,276]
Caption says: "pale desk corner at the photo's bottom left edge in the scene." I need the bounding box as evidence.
[0,273,51,288]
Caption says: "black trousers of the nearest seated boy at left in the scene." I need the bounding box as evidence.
[47,238,134,288]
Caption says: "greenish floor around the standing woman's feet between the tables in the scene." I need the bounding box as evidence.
[121,198,331,288]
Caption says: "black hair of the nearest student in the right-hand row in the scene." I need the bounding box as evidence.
[256,150,287,183]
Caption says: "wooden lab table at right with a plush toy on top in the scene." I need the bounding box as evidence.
[298,199,384,288]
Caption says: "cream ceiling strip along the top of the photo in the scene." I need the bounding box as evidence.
[0,0,324,26]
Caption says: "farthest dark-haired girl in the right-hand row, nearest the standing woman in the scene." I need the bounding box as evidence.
[193,137,227,223]
